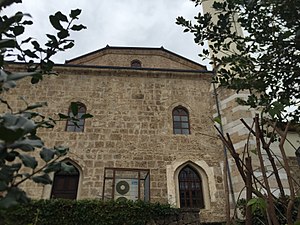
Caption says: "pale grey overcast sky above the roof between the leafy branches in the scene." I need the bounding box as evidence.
[4,0,209,64]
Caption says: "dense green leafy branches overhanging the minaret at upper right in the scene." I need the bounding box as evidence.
[177,0,300,122]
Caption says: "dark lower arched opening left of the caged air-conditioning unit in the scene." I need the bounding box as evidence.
[51,162,79,199]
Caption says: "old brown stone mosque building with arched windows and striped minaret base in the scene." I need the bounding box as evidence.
[7,43,299,222]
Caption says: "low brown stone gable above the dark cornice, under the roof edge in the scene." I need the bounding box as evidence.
[66,45,206,70]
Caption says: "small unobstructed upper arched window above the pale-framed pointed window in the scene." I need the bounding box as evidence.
[172,106,190,134]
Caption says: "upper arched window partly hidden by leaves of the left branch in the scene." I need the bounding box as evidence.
[66,102,86,132]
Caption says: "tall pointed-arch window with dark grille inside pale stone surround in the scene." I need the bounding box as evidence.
[178,165,204,209]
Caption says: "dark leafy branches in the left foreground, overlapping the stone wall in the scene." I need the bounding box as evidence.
[0,0,92,208]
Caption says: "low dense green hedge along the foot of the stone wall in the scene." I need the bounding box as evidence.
[0,199,179,225]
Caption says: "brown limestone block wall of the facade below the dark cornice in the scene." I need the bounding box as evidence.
[2,66,225,222]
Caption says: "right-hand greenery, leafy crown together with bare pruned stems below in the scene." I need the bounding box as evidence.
[177,0,300,225]
